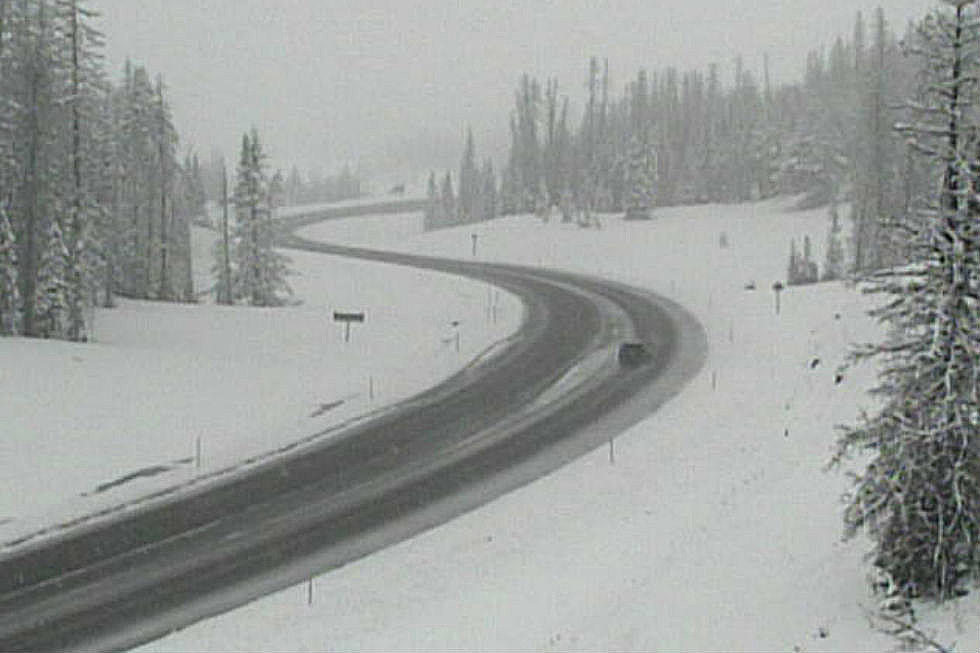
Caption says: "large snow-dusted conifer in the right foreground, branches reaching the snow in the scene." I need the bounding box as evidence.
[834,0,980,600]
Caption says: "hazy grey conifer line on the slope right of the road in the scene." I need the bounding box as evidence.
[500,9,929,270]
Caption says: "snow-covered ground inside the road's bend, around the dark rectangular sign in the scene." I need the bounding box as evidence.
[0,222,522,552]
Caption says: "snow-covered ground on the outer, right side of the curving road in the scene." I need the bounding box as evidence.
[144,201,980,651]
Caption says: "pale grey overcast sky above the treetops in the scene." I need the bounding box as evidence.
[91,0,934,186]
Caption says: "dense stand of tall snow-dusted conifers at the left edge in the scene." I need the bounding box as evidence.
[0,0,203,341]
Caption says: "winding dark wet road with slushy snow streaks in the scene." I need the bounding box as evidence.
[0,202,706,651]
